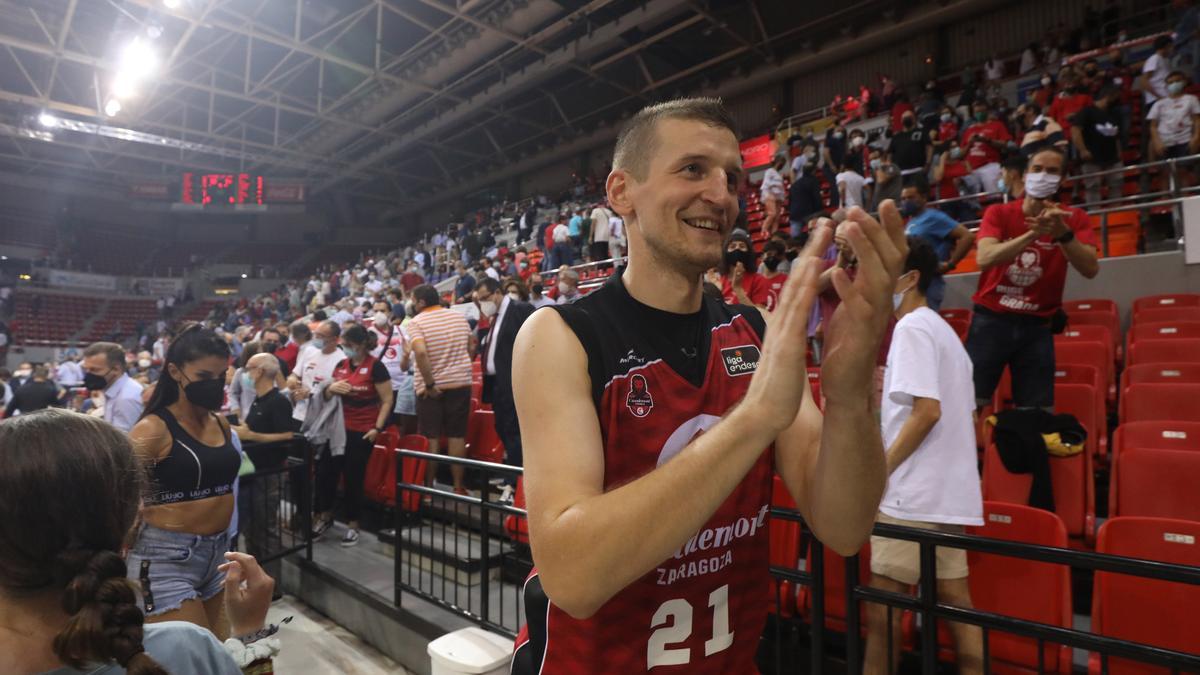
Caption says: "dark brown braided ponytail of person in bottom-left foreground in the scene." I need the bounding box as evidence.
[53,549,167,675]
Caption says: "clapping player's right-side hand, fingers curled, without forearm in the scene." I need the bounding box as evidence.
[825,199,908,401]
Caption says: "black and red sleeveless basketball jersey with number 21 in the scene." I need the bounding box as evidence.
[512,270,774,675]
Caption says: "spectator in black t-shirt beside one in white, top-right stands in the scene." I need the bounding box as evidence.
[1070,85,1124,204]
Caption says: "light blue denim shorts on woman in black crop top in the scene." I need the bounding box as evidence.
[126,525,229,616]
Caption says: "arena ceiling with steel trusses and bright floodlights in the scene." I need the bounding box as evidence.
[0,0,913,208]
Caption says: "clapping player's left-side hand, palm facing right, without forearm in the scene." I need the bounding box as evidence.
[745,219,833,431]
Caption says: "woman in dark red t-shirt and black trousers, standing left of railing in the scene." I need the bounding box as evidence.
[320,324,394,546]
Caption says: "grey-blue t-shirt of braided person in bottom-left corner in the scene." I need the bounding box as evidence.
[42,621,241,675]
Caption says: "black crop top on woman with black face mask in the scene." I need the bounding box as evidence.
[148,408,241,504]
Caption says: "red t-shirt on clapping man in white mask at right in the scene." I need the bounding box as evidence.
[972,199,1096,316]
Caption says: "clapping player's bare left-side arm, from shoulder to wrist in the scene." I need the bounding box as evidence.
[512,311,777,619]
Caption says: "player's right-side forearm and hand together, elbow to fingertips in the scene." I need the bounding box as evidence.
[772,205,907,555]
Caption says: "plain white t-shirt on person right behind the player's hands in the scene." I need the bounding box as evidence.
[880,307,983,525]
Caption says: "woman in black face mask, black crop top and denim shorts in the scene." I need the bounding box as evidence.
[128,324,241,640]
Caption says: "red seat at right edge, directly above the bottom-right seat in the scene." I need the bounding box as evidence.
[1109,448,1200,521]
